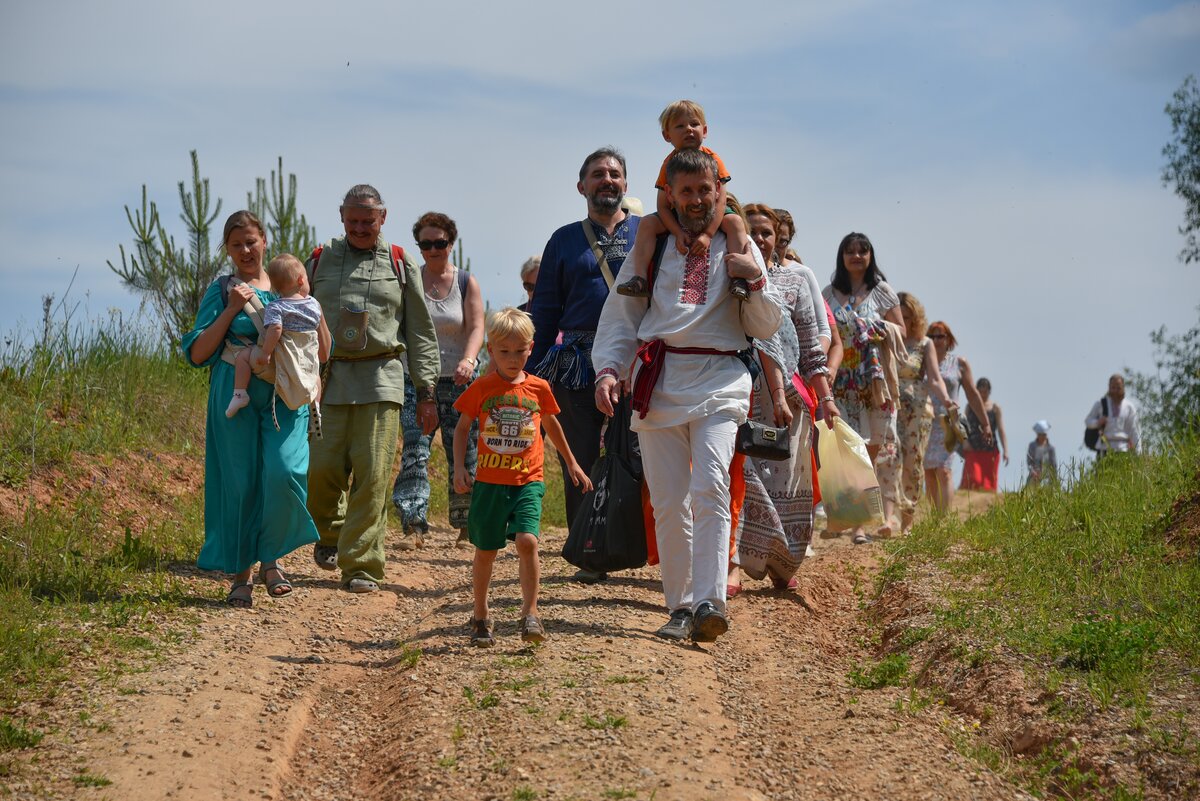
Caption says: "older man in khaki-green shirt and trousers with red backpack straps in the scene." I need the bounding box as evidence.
[306,183,439,592]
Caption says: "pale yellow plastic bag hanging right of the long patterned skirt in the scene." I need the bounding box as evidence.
[817,417,883,531]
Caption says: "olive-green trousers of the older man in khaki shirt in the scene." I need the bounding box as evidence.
[308,401,400,586]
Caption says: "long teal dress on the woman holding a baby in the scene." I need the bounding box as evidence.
[182,282,317,573]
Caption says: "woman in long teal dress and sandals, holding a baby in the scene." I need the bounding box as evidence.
[182,211,317,608]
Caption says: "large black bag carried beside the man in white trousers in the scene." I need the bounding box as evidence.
[563,399,647,573]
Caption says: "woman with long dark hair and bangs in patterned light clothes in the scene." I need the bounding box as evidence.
[821,231,905,544]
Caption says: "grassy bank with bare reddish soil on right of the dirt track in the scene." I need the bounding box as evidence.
[860,436,1200,799]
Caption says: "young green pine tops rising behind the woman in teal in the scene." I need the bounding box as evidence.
[108,150,317,348]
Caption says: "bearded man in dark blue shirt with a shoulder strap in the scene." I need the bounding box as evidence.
[529,147,644,583]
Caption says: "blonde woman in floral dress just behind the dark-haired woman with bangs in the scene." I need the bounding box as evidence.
[896,293,958,532]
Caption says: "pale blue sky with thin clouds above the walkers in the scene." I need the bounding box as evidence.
[0,0,1200,487]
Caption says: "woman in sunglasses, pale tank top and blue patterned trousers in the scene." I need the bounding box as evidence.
[391,211,484,550]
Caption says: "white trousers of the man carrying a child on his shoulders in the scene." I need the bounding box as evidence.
[637,415,738,613]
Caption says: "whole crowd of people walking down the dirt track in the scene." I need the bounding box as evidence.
[182,101,1139,646]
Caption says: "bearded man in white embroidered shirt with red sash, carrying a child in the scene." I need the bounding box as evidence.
[592,150,782,643]
